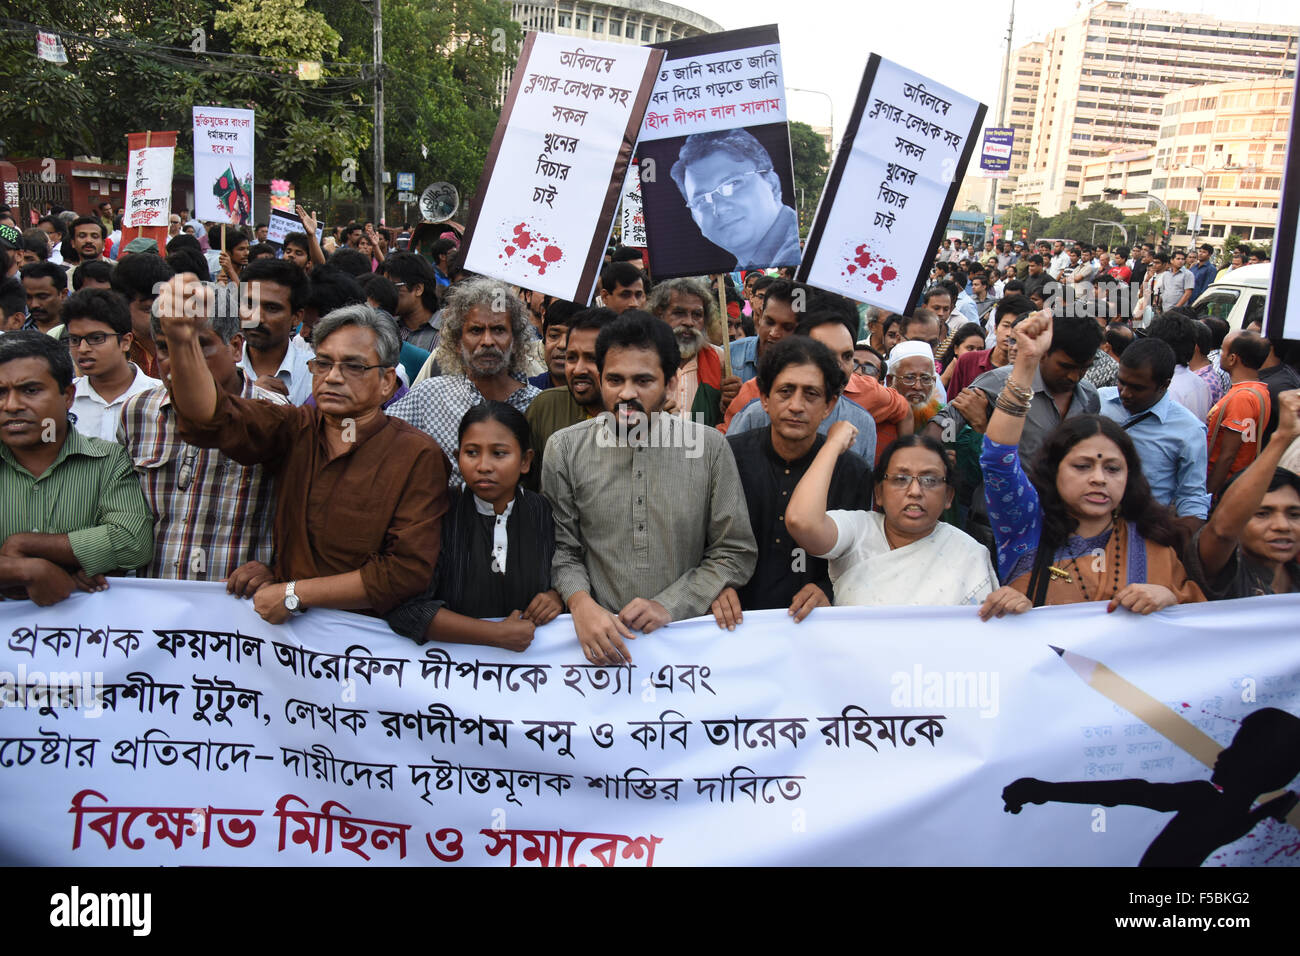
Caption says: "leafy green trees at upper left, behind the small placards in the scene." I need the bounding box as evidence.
[0,0,523,222]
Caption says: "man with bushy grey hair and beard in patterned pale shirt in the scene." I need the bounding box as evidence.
[387,278,541,488]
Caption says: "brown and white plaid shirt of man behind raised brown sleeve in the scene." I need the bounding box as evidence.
[117,375,286,581]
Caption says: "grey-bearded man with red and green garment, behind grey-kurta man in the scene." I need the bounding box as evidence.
[646,278,741,427]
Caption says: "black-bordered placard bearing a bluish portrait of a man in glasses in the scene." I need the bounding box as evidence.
[637,25,800,278]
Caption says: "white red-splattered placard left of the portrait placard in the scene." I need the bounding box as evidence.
[462,33,663,303]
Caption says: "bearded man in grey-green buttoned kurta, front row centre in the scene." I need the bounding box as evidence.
[542,310,758,665]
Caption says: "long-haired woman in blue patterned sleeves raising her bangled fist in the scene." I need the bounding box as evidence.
[980,312,1205,620]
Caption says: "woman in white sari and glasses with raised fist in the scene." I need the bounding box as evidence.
[785,421,998,605]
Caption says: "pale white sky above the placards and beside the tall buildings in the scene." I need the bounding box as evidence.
[676,0,1300,149]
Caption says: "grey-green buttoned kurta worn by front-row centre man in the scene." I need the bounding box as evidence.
[542,414,758,620]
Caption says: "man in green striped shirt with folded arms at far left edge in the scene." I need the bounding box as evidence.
[0,332,153,606]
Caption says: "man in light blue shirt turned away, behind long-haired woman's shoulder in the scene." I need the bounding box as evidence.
[1097,338,1210,532]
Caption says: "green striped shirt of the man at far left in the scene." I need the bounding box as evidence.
[0,425,153,575]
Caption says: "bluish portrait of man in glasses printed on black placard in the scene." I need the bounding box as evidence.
[671,129,800,269]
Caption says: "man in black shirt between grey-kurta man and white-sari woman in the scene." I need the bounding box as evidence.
[712,336,871,628]
